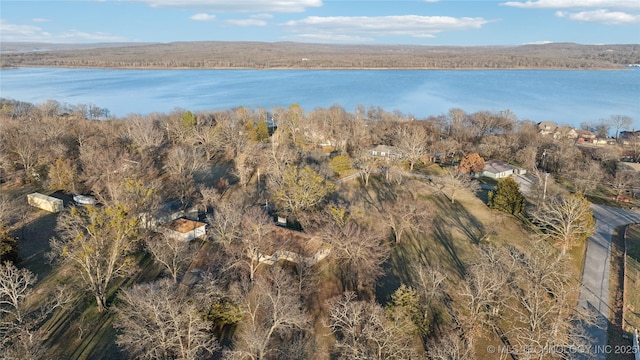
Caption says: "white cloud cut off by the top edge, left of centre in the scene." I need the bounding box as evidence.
[131,0,322,13]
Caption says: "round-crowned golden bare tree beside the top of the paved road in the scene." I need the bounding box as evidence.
[532,193,595,255]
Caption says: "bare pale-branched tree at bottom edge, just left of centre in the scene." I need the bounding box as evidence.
[226,266,311,360]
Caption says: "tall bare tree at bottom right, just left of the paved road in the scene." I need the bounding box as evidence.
[507,241,593,359]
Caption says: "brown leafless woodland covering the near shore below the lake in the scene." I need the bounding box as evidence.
[0,99,640,359]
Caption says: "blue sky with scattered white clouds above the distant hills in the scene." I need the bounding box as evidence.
[0,0,640,45]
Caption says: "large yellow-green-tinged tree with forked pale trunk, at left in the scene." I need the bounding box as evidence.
[50,206,138,312]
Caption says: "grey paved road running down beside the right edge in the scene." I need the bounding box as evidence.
[580,205,640,359]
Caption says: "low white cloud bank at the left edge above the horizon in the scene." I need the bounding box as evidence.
[0,19,127,43]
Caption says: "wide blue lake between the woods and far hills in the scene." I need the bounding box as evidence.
[0,68,640,128]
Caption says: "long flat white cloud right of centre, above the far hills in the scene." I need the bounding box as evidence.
[282,15,490,39]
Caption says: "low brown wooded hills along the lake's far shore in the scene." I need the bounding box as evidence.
[0,42,640,70]
